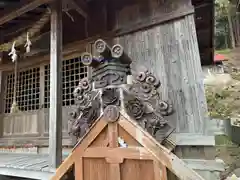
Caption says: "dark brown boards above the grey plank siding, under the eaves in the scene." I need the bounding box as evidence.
[115,0,194,36]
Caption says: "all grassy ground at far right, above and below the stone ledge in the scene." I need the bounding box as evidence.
[208,48,240,177]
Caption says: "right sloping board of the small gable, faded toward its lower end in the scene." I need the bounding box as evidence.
[119,111,203,180]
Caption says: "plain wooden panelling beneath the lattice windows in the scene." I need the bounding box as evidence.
[0,83,72,147]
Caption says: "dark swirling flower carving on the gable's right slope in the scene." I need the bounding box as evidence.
[124,70,174,141]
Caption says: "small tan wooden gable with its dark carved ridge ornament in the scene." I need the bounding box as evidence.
[52,40,203,180]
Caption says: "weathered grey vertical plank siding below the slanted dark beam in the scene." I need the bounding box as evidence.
[115,3,207,133]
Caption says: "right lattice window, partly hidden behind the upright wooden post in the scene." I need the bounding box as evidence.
[44,57,87,108]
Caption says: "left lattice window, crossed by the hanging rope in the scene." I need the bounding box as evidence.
[4,67,40,113]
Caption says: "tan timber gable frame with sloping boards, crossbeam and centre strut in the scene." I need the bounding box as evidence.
[51,110,204,180]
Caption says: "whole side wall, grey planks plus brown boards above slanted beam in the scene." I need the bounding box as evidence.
[110,0,207,133]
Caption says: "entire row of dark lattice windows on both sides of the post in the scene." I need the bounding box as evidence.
[4,57,88,113]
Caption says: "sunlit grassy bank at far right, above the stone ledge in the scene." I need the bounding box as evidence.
[205,48,240,119]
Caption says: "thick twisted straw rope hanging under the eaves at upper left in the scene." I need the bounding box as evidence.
[0,8,51,52]
